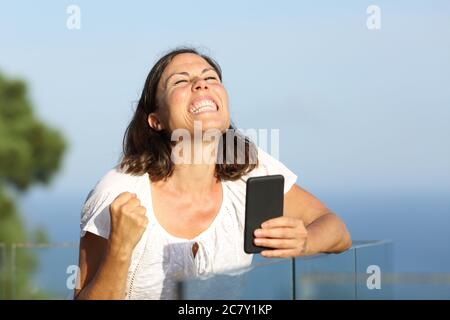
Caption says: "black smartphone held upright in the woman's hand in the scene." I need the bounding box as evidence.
[244,174,284,253]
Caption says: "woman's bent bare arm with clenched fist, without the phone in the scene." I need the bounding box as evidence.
[75,192,148,300]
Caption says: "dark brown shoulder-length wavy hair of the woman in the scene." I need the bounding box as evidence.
[120,47,258,181]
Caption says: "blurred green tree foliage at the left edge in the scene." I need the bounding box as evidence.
[0,73,66,299]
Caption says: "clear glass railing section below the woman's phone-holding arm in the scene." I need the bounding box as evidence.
[178,241,393,300]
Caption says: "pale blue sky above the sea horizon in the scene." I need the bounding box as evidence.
[0,1,450,242]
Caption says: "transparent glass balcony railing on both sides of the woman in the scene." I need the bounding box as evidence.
[0,241,450,300]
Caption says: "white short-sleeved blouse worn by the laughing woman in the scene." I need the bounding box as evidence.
[80,148,297,299]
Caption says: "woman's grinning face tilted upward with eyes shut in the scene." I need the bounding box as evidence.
[153,53,230,133]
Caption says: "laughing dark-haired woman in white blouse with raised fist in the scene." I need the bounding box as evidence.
[75,48,351,299]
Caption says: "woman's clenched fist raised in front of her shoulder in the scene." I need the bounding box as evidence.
[109,192,148,256]
